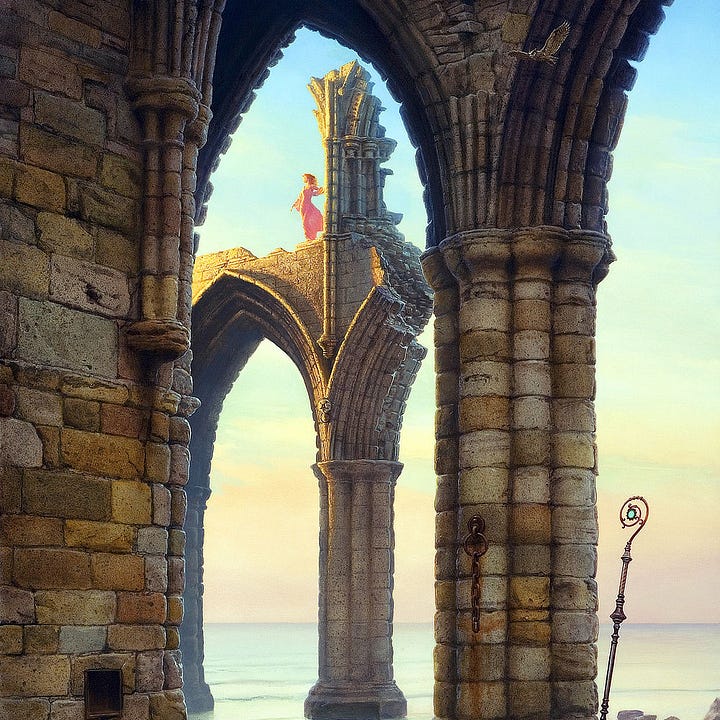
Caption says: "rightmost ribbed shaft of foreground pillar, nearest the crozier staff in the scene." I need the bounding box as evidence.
[550,231,612,720]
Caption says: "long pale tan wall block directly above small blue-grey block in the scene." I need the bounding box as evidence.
[35,590,115,625]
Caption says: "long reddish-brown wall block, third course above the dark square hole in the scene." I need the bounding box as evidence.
[13,548,91,589]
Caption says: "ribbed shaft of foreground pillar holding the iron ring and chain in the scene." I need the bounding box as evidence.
[440,231,512,720]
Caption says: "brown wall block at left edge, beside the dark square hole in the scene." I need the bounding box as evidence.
[0,655,70,697]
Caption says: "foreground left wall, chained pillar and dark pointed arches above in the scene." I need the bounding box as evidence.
[0,0,670,720]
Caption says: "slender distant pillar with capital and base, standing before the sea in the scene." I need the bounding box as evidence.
[305,460,407,720]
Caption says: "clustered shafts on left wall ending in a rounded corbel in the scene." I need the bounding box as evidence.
[126,0,224,360]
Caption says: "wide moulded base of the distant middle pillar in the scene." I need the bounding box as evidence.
[305,682,407,720]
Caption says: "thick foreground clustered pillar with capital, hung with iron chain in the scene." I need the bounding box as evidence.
[423,227,611,720]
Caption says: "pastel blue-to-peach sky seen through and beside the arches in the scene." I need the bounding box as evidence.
[194,0,720,623]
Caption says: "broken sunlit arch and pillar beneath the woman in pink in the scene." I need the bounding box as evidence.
[182,63,432,718]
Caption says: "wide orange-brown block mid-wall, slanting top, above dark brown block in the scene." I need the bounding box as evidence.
[61,428,149,480]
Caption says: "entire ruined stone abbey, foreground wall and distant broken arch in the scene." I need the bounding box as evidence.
[0,0,671,720]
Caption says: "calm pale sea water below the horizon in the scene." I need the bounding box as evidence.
[191,624,720,720]
